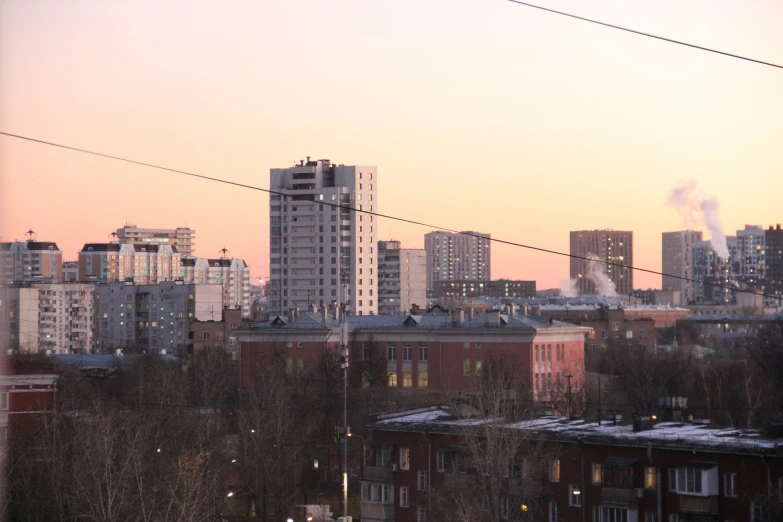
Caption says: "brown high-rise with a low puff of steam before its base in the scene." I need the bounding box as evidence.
[570,230,633,295]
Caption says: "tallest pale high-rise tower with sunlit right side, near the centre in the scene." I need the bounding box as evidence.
[269,157,378,315]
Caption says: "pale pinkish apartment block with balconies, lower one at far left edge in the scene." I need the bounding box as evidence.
[0,283,94,354]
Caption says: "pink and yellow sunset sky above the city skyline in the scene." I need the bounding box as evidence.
[0,0,783,288]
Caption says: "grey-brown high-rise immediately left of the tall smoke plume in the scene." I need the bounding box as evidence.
[661,230,703,304]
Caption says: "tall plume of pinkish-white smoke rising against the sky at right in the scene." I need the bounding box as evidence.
[666,179,729,259]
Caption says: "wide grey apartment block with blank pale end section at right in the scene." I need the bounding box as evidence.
[94,281,223,355]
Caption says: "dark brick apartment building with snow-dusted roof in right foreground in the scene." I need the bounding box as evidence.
[361,406,783,522]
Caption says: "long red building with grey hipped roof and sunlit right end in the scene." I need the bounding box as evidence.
[234,304,589,394]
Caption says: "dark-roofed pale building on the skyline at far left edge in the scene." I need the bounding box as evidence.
[0,235,63,283]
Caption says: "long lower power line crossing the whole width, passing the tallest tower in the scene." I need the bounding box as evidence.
[0,130,780,299]
